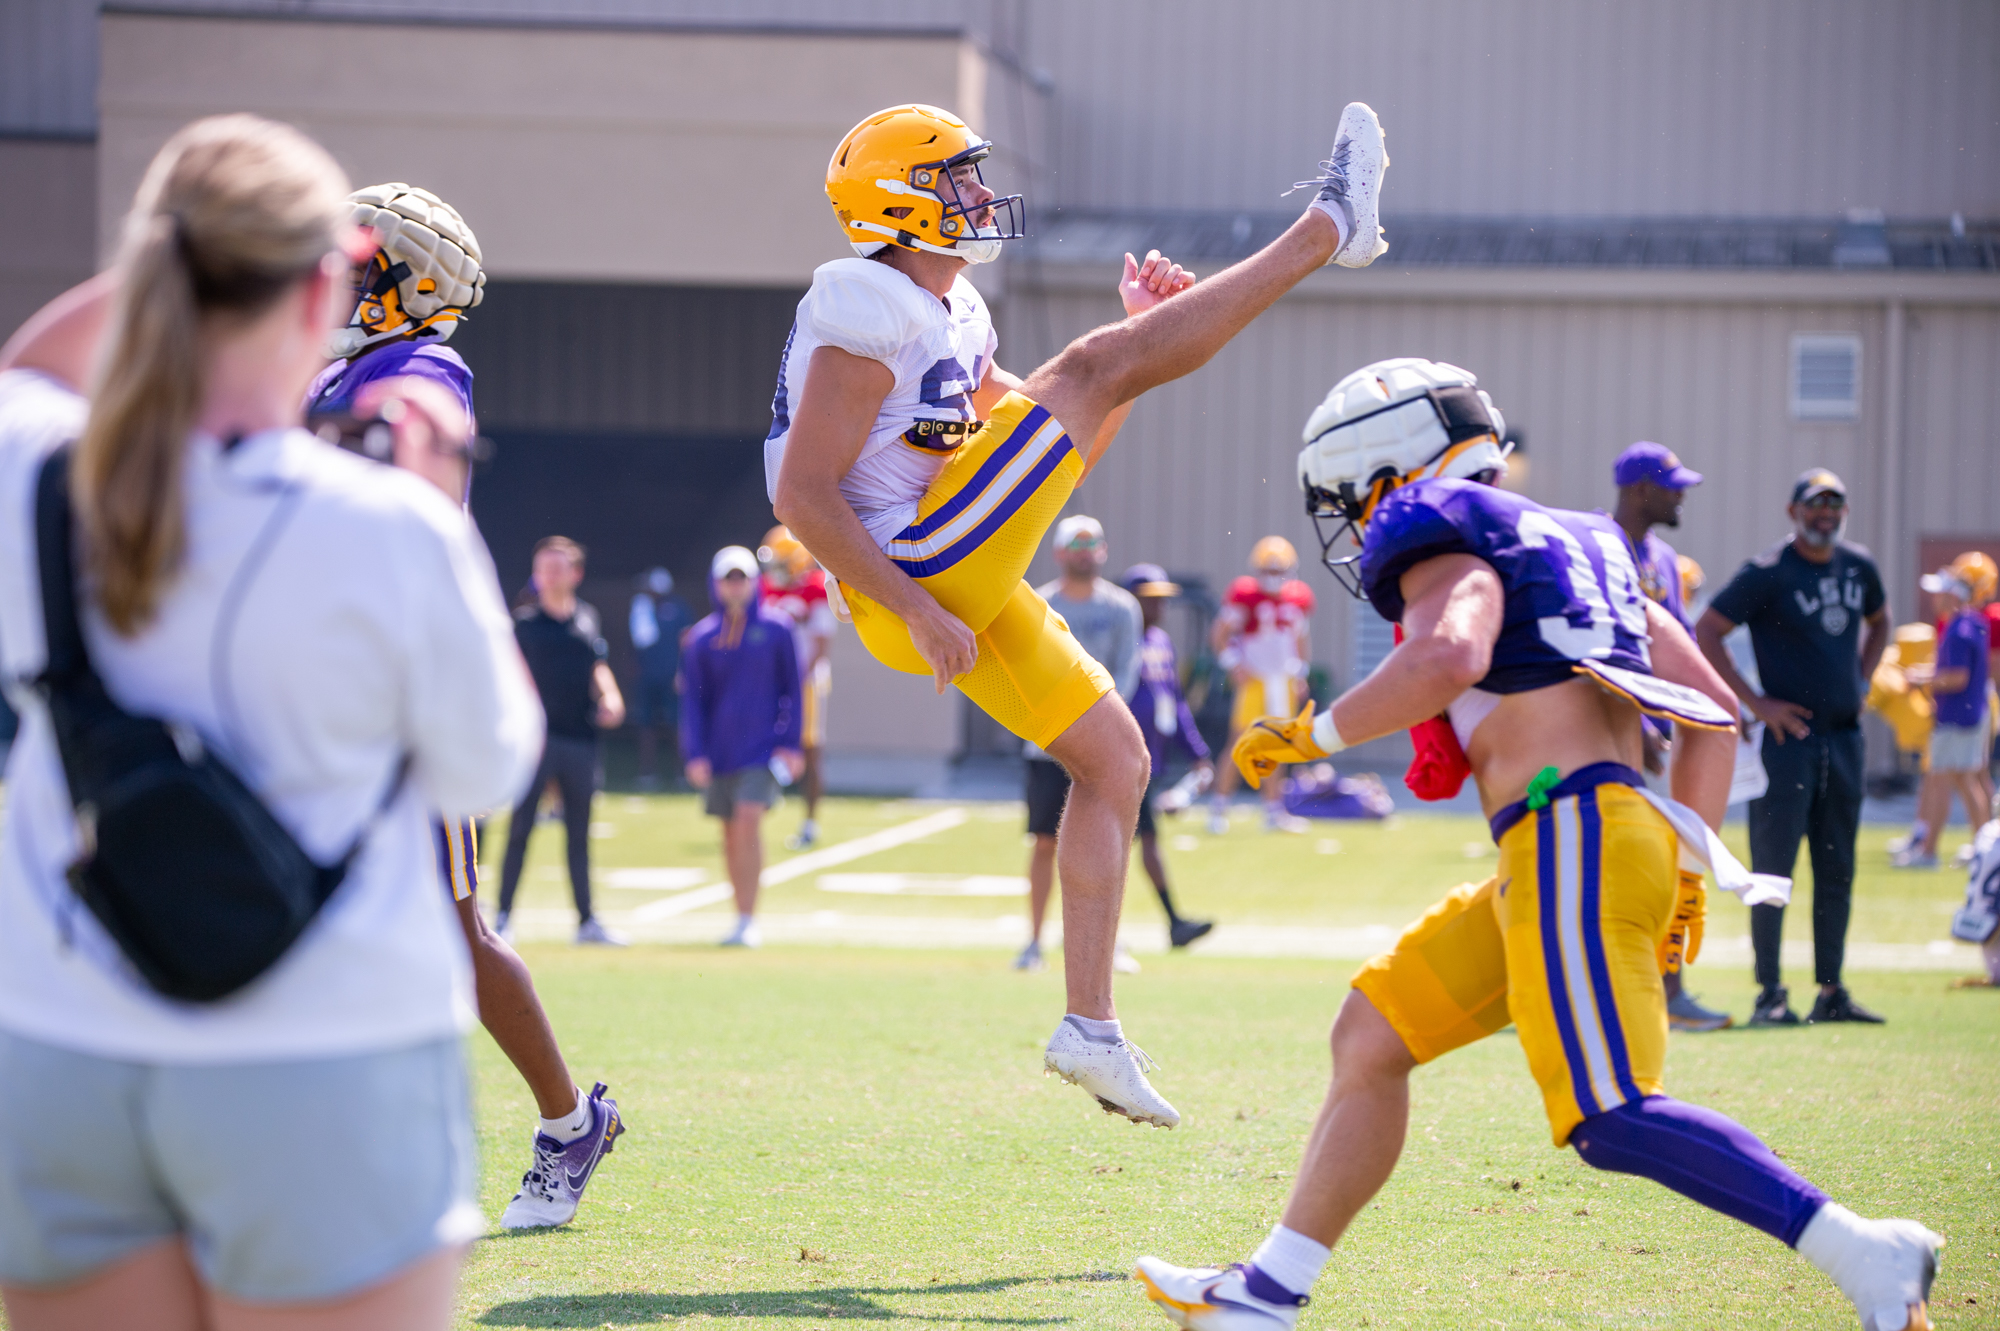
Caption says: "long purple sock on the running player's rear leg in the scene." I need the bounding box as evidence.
[1570,1095,1828,1245]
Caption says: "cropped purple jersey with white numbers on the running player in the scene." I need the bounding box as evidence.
[1360,478,1652,693]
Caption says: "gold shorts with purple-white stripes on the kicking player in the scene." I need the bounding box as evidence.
[840,394,1114,747]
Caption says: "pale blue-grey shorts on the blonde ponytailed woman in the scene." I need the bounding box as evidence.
[0,1031,486,1303]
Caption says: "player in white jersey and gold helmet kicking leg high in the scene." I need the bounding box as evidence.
[764,102,1388,1127]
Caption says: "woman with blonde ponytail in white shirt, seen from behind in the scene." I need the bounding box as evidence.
[0,116,542,1331]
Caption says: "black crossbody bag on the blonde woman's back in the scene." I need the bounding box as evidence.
[34,448,410,1003]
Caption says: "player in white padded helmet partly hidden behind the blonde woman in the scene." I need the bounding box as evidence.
[306,182,624,1229]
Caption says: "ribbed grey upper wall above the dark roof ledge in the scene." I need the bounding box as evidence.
[1030,0,2000,216]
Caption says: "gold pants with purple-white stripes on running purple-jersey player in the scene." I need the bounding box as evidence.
[1354,767,1680,1145]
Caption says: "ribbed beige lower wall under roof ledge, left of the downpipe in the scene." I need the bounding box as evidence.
[1000,296,1896,677]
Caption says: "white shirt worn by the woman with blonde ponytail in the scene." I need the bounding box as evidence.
[0,370,542,1063]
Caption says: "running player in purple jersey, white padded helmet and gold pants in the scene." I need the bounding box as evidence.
[1138,360,1942,1331]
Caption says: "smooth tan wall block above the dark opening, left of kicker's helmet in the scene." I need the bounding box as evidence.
[98,14,1000,286]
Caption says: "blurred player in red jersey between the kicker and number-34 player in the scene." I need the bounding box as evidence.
[1208,536,1314,835]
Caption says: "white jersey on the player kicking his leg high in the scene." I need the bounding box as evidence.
[764,258,1000,546]
